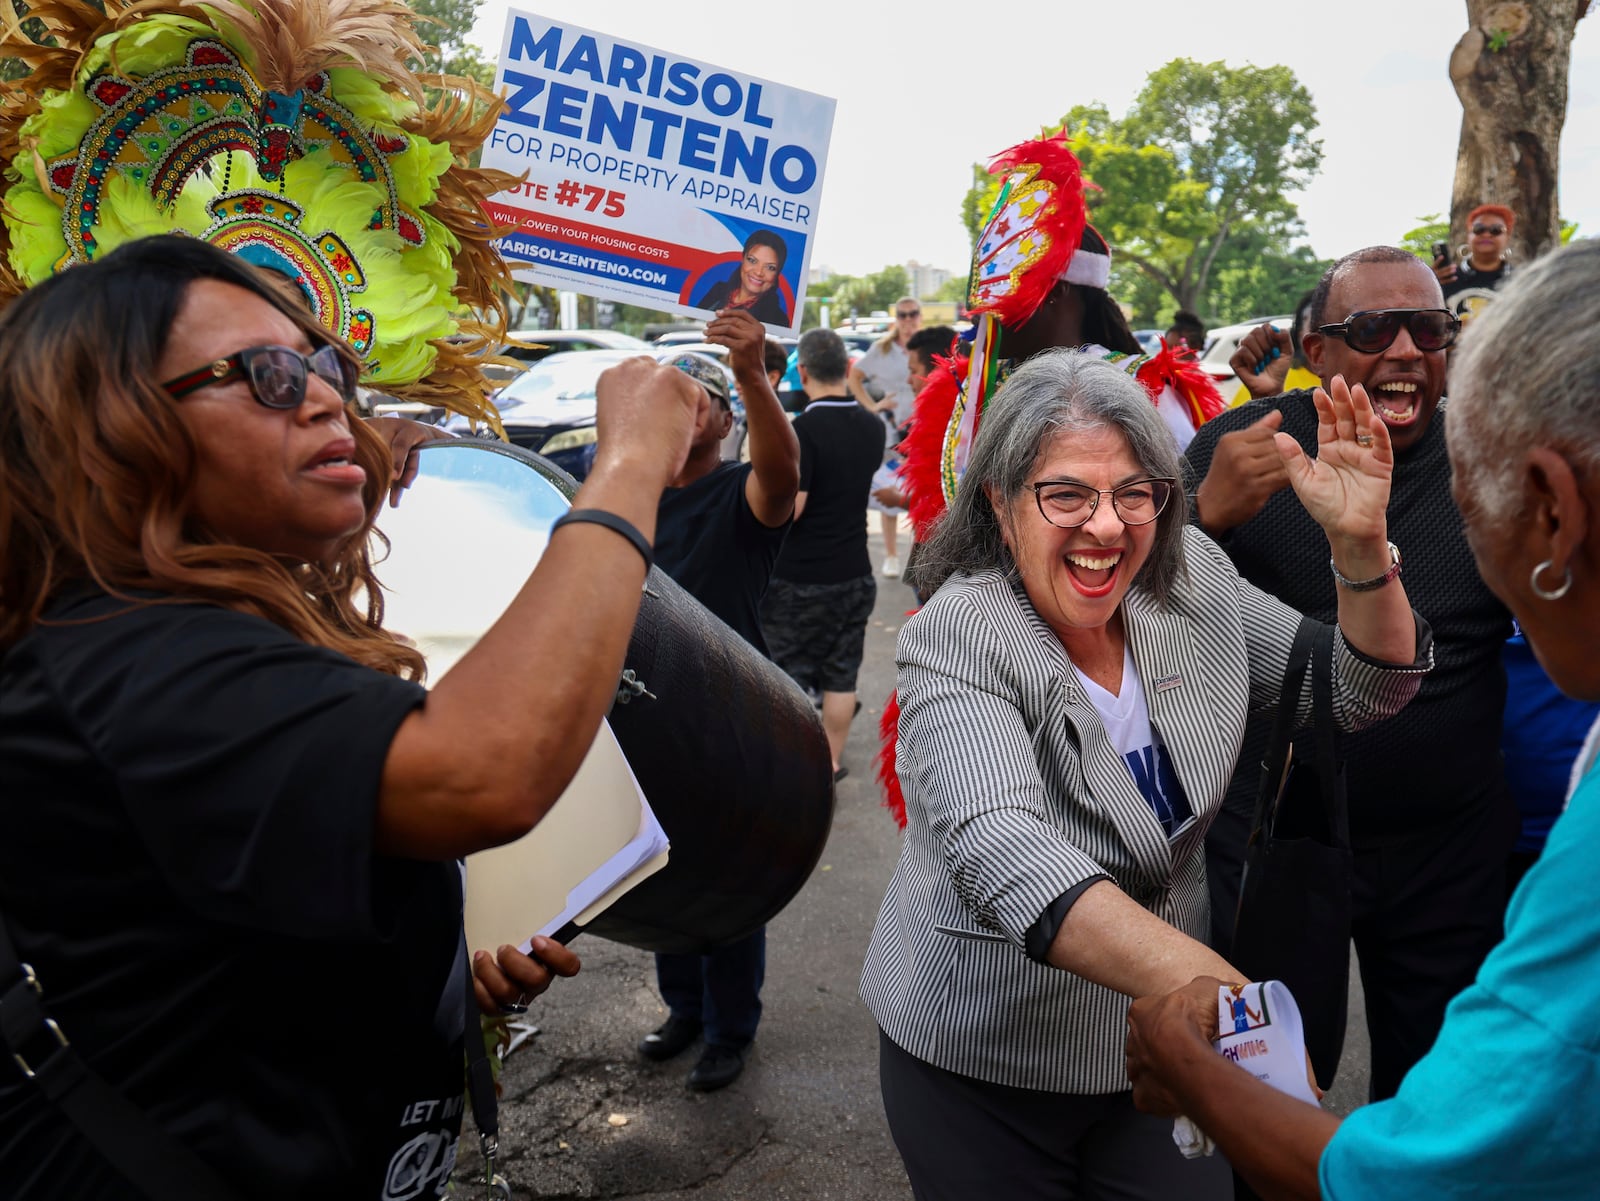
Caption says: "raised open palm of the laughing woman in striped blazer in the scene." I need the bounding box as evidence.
[1274,376,1395,547]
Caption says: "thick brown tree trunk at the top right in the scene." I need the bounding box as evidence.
[1450,0,1589,262]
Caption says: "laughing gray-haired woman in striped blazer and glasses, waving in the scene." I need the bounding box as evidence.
[861,350,1432,1201]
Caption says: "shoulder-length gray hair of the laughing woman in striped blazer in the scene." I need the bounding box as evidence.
[917,349,1189,608]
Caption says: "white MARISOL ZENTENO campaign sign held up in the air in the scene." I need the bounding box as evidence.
[483,10,834,333]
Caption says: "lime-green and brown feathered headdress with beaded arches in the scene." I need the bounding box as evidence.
[0,0,512,421]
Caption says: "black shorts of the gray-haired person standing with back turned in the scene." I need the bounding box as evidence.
[762,576,878,692]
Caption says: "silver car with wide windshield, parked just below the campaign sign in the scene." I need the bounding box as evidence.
[445,345,746,480]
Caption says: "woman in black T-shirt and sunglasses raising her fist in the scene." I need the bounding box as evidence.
[0,237,704,1199]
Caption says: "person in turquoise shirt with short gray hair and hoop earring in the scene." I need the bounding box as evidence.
[1128,238,1600,1201]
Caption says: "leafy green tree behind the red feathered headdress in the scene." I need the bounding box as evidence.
[963,59,1322,318]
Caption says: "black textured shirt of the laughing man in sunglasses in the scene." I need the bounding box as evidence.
[1184,390,1512,844]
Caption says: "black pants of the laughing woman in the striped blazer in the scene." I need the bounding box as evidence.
[878,1030,1232,1201]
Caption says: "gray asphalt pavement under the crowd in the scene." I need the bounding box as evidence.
[458,520,1366,1201]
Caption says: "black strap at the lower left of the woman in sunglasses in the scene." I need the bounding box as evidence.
[0,913,248,1201]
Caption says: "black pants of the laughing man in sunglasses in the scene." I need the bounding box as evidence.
[1206,798,1515,1100]
